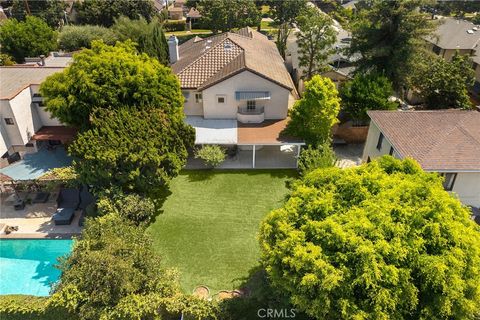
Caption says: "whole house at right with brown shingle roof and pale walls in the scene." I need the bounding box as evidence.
[363,110,480,207]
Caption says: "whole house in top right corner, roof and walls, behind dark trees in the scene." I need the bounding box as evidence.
[426,17,480,61]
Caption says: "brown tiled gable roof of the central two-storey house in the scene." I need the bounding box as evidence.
[172,27,295,91]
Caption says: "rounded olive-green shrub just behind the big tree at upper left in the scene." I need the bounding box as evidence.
[58,25,118,51]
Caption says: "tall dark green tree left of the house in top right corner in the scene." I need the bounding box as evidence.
[350,0,435,89]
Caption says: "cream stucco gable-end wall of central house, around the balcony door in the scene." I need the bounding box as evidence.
[203,71,294,119]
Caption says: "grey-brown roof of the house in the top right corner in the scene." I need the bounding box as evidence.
[427,18,480,50]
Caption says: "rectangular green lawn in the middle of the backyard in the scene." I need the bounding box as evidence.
[148,170,296,293]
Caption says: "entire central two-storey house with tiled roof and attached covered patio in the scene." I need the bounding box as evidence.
[168,28,303,167]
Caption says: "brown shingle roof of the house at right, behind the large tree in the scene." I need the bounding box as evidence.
[368,110,480,172]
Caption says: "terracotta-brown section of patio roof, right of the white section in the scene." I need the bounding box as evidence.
[238,118,305,145]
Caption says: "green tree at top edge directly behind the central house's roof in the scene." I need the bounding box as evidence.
[197,0,261,33]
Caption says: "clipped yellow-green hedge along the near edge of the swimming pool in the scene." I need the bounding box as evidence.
[0,295,78,320]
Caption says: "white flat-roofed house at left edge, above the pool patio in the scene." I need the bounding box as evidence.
[0,56,73,167]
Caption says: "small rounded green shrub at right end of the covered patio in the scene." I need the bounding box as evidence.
[298,143,336,176]
